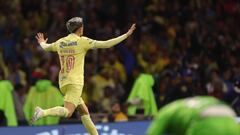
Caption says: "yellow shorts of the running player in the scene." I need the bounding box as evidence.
[60,84,84,107]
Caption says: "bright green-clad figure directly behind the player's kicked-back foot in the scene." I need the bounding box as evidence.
[23,80,63,125]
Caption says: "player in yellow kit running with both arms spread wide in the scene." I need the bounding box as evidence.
[32,17,135,135]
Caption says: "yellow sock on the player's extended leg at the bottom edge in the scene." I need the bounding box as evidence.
[81,115,98,135]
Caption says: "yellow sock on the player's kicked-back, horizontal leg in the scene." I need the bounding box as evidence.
[43,106,68,117]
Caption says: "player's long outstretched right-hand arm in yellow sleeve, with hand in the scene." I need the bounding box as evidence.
[93,24,136,48]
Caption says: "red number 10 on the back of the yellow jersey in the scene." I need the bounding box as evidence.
[60,55,75,73]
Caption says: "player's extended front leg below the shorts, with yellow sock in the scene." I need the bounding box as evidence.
[77,98,98,135]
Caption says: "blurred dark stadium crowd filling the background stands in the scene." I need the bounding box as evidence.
[0,0,240,126]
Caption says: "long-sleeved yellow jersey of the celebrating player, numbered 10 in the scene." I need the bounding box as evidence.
[40,33,127,88]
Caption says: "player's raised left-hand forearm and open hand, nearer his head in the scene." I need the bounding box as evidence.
[35,33,53,51]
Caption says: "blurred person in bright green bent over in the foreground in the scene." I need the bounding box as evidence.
[147,96,240,135]
